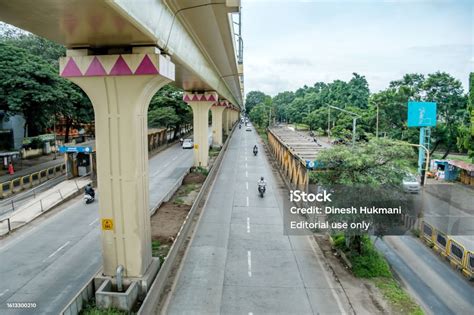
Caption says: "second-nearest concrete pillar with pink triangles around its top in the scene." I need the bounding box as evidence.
[183,92,218,168]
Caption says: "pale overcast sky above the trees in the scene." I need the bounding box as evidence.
[242,0,474,95]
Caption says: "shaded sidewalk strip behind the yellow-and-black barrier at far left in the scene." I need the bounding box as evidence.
[0,154,64,183]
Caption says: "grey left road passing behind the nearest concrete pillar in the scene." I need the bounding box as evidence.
[0,144,193,314]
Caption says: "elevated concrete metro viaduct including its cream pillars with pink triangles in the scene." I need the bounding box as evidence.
[0,0,243,292]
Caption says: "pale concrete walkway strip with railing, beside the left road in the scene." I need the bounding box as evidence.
[0,177,90,236]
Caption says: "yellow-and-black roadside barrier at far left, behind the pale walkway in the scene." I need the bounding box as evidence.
[0,163,66,199]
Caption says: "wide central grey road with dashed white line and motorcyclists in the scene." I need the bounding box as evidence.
[162,129,349,314]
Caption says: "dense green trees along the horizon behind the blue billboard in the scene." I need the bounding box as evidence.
[247,72,468,156]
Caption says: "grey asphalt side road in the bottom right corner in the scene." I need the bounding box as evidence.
[375,236,474,315]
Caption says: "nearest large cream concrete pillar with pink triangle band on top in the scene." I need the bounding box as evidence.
[60,47,174,277]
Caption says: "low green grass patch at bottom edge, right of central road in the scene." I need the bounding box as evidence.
[372,278,424,315]
